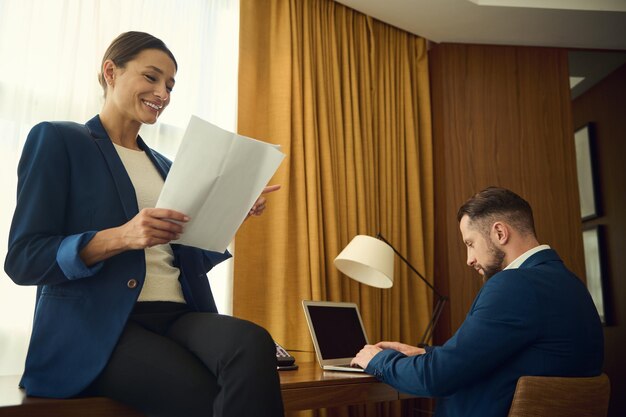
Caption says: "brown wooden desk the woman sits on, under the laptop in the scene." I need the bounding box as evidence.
[0,353,409,417]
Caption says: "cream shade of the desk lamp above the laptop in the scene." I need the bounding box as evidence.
[335,235,394,288]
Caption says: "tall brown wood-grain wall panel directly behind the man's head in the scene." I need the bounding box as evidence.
[429,44,584,341]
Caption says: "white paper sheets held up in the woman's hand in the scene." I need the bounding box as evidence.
[156,116,285,252]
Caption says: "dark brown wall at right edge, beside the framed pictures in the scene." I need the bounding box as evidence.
[572,61,626,417]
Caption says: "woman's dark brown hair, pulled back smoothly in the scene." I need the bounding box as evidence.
[98,32,178,97]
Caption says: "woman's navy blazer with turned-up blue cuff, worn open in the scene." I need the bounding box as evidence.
[5,116,230,398]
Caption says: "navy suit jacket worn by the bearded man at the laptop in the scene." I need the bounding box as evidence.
[366,249,604,417]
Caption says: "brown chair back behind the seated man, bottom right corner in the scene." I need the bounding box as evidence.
[509,374,611,417]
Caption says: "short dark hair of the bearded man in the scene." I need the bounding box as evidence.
[456,187,535,236]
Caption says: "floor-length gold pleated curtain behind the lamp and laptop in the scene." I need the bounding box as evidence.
[234,0,434,410]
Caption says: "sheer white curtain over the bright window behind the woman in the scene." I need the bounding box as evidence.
[0,0,239,375]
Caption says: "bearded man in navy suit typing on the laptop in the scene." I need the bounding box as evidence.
[353,187,604,417]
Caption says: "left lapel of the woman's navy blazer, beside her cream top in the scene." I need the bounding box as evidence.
[85,116,139,220]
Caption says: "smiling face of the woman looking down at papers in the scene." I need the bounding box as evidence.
[107,49,176,124]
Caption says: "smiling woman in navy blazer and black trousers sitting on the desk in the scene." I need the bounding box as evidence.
[5,25,283,417]
